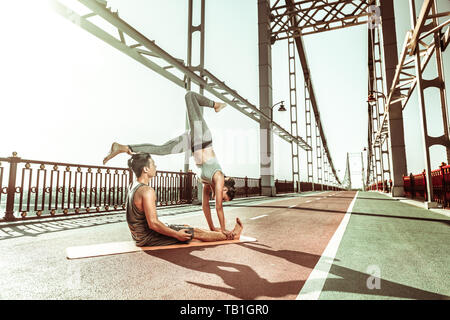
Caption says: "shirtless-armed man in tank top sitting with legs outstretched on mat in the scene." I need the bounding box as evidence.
[126,153,243,247]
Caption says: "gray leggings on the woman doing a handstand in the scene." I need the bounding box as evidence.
[128,91,214,155]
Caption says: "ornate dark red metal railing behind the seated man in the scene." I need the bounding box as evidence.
[0,153,197,221]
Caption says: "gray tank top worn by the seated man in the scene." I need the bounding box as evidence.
[127,183,154,247]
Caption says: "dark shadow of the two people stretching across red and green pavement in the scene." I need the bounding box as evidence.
[146,243,449,300]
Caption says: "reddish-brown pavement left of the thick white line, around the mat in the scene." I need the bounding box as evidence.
[0,191,355,300]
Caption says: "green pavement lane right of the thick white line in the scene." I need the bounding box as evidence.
[319,192,450,300]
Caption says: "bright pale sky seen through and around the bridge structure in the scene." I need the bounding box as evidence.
[0,0,450,187]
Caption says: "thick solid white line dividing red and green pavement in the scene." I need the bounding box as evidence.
[296,191,359,300]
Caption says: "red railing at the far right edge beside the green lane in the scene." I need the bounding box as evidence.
[403,163,450,207]
